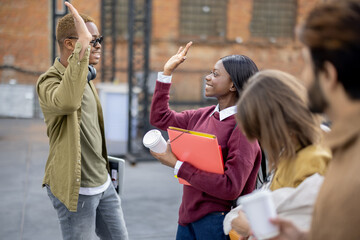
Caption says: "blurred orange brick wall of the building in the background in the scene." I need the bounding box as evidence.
[0,0,318,101]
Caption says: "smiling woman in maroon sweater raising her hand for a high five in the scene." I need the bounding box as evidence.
[150,42,261,240]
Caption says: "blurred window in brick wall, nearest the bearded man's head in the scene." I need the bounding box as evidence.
[250,0,297,41]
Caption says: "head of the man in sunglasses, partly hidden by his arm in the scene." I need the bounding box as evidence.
[56,13,102,65]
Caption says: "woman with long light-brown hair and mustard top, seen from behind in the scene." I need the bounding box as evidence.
[224,70,331,237]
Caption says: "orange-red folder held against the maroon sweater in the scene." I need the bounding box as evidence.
[167,127,224,185]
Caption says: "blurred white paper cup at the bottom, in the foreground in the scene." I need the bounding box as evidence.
[240,190,279,239]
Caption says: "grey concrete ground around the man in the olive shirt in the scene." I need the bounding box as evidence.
[0,118,182,240]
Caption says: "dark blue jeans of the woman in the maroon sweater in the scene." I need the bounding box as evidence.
[176,212,230,240]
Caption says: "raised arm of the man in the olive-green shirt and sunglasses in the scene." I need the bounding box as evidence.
[37,2,92,115]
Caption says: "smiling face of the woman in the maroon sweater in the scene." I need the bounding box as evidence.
[205,60,236,99]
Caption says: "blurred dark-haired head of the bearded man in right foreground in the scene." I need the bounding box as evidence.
[300,0,360,112]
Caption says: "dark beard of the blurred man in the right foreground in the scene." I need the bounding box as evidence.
[308,76,328,113]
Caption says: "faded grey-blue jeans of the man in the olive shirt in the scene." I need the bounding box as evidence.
[47,184,128,240]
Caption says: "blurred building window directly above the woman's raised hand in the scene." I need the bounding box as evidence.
[180,0,227,40]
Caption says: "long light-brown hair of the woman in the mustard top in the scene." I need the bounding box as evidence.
[236,70,321,168]
